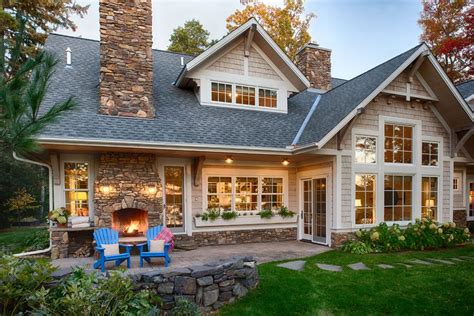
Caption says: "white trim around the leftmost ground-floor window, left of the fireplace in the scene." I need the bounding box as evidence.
[58,154,95,220]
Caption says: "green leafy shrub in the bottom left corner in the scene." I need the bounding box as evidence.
[0,256,55,315]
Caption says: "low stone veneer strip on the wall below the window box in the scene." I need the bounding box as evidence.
[175,227,297,247]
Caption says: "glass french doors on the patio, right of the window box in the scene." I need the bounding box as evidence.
[301,178,327,244]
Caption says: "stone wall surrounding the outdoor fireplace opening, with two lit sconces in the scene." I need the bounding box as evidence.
[94,153,163,227]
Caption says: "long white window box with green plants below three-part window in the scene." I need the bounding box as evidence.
[194,206,298,227]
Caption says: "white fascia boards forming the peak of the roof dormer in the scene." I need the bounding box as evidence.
[175,18,311,88]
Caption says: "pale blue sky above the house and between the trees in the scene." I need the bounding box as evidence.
[57,0,422,79]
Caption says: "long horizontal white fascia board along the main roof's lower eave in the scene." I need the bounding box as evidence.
[37,137,292,155]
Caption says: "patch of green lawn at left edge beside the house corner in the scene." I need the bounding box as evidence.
[0,227,49,254]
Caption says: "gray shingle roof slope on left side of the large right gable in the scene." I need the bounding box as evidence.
[298,44,423,146]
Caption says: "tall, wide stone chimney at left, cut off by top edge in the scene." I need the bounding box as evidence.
[99,0,155,118]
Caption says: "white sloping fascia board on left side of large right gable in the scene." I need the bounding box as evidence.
[297,44,429,150]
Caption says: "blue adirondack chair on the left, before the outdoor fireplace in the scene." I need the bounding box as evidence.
[94,228,132,272]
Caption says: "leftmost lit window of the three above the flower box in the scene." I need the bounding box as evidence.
[207,177,232,210]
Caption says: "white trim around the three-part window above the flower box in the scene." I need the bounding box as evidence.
[202,168,288,213]
